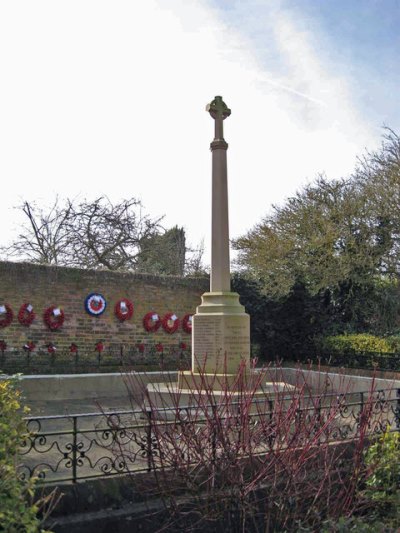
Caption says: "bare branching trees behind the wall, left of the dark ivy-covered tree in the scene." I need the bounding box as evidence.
[1,197,162,270]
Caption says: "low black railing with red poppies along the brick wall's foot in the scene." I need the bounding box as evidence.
[0,344,190,374]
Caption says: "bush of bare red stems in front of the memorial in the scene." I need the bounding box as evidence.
[126,364,388,533]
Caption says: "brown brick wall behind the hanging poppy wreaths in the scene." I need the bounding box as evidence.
[0,262,209,353]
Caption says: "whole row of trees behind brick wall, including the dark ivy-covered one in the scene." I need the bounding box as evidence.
[0,196,212,276]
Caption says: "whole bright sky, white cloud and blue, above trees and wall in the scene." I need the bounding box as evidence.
[0,0,400,263]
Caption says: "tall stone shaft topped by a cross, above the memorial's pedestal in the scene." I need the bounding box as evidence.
[206,96,231,292]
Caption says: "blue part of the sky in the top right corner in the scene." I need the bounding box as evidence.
[215,0,400,131]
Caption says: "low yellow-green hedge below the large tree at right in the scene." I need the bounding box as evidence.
[321,333,395,355]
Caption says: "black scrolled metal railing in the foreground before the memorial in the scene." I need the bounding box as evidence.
[19,389,400,483]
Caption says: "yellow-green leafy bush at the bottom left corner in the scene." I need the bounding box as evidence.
[0,379,52,533]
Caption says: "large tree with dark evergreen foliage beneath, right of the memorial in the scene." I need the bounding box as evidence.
[234,130,400,358]
